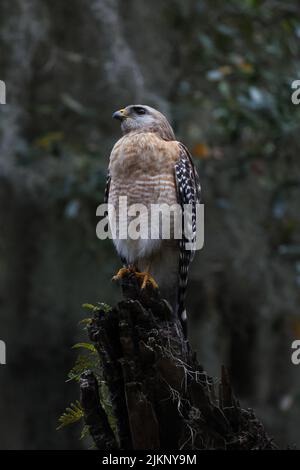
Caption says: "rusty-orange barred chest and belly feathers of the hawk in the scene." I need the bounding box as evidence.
[108,132,179,263]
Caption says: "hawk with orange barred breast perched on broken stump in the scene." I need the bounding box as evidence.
[105,105,200,332]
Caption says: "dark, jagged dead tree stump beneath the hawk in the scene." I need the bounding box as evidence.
[80,275,276,450]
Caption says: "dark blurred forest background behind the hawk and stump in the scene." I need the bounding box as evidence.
[0,0,300,449]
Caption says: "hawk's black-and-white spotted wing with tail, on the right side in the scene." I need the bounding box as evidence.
[175,143,201,319]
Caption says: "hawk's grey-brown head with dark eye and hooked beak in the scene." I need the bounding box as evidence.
[113,104,175,140]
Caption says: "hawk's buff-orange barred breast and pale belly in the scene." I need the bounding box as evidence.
[108,133,178,262]
